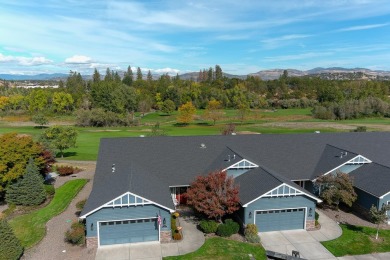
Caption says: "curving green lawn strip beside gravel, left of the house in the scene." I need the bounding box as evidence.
[9,179,87,248]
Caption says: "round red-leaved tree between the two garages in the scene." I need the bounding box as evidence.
[187,171,240,221]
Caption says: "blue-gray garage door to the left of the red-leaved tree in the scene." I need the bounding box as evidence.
[99,218,158,245]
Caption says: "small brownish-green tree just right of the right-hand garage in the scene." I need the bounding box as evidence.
[316,172,357,209]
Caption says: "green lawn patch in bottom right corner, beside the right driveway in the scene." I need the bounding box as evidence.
[321,224,390,257]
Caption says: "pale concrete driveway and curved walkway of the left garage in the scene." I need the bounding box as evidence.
[96,217,205,260]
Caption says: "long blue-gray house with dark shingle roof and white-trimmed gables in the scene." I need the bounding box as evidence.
[81,132,390,246]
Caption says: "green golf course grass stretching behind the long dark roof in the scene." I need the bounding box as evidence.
[0,109,390,160]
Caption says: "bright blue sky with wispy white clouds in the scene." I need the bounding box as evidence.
[0,0,390,74]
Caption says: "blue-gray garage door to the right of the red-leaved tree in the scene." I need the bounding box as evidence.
[255,208,305,232]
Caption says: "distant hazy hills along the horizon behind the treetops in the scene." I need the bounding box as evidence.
[0,67,390,81]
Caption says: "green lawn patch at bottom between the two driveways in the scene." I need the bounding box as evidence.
[164,237,267,260]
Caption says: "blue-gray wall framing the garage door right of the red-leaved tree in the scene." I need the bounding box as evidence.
[239,195,316,229]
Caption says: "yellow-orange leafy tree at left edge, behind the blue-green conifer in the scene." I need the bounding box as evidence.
[0,133,53,197]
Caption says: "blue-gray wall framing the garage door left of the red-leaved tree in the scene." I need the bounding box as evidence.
[86,204,171,237]
